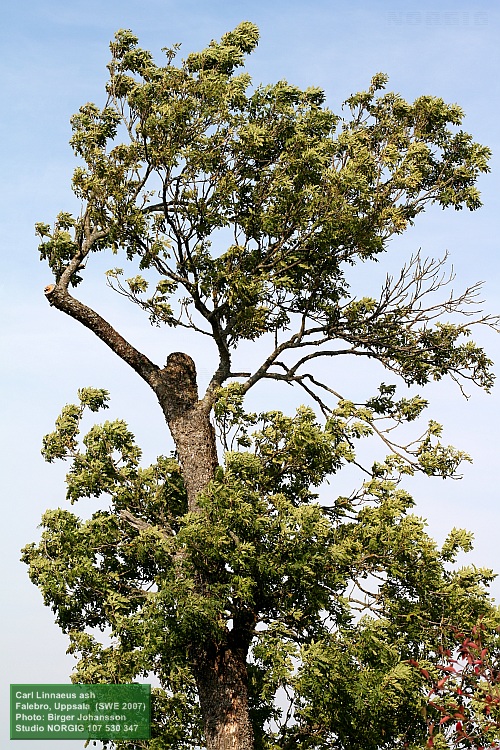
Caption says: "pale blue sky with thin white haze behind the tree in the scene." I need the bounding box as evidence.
[0,0,500,750]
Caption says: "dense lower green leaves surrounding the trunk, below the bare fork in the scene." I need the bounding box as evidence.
[23,394,500,750]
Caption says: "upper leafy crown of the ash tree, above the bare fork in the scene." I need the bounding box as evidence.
[37,22,492,388]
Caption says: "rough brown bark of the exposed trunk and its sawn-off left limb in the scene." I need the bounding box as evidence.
[45,285,253,750]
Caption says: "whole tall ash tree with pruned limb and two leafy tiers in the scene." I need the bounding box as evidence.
[23,22,499,750]
